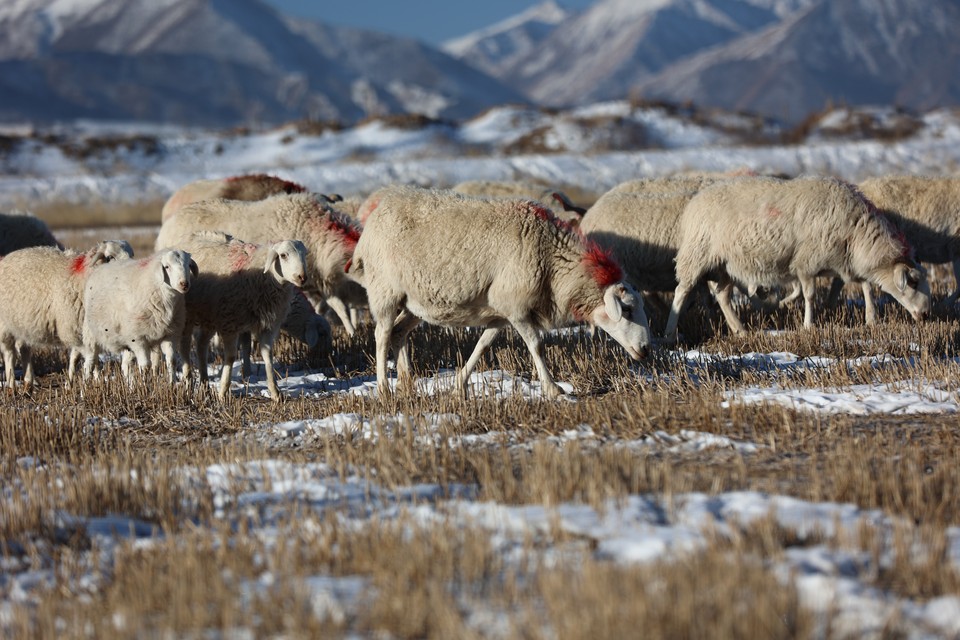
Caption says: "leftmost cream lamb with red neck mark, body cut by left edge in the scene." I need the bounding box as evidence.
[0,240,133,390]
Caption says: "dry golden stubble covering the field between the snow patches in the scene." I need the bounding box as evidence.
[0,220,960,638]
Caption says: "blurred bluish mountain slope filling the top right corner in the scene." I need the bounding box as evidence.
[640,0,960,121]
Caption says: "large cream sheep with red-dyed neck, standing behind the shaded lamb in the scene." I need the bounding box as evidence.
[156,193,366,336]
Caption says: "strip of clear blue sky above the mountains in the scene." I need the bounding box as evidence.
[258,0,593,45]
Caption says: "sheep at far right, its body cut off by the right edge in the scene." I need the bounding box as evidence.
[859,176,960,306]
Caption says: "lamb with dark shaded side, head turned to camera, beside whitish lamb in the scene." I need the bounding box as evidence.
[180,232,306,401]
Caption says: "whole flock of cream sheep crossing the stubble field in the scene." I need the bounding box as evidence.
[0,174,960,400]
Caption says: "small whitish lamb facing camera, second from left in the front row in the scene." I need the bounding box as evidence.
[83,249,198,384]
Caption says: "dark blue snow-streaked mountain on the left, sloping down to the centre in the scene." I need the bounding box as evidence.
[0,0,523,126]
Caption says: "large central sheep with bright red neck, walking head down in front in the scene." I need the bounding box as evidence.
[348,182,650,398]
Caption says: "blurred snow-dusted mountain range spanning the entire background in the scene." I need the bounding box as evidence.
[0,0,960,127]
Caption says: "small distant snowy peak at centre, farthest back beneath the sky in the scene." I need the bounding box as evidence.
[441,0,574,76]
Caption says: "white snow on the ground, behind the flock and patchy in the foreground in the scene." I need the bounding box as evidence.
[0,104,960,637]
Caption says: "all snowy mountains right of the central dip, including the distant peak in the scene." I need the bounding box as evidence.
[444,0,960,122]
